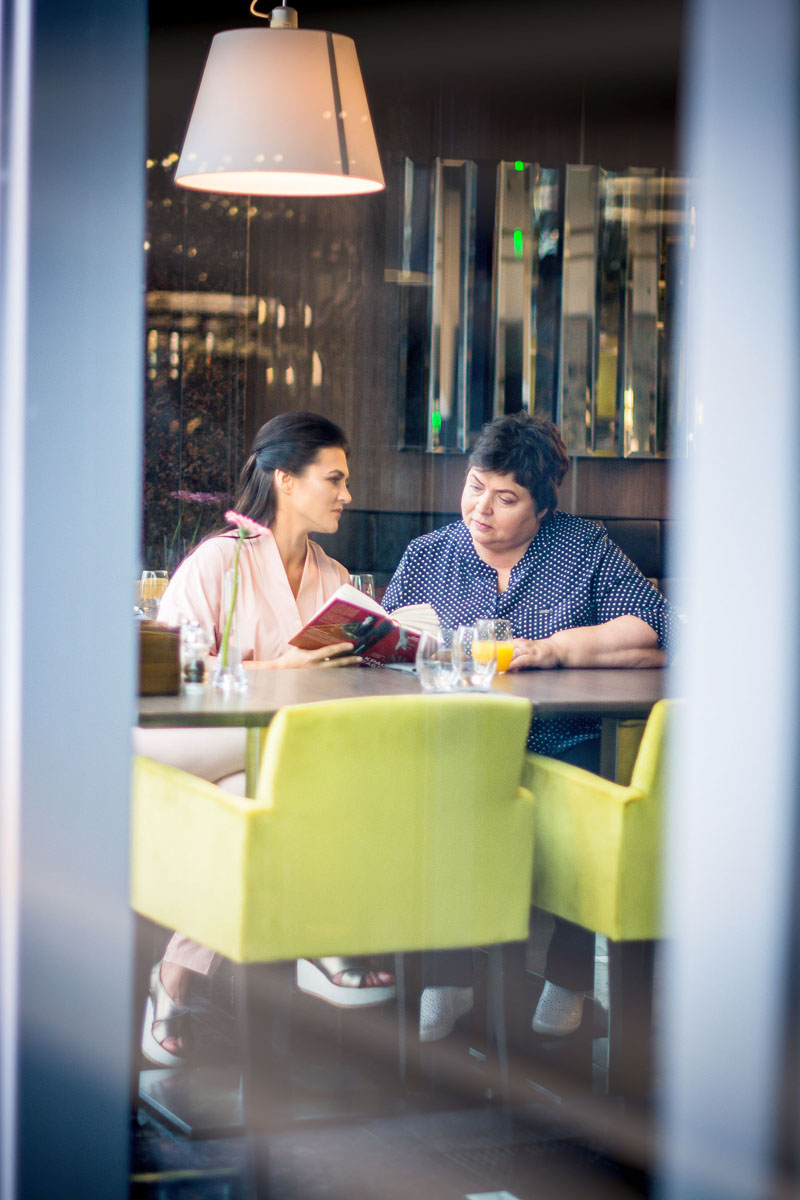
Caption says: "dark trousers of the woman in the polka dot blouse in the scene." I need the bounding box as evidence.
[422,738,600,991]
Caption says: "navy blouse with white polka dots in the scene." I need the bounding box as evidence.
[383,512,679,755]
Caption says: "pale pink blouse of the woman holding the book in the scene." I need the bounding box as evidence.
[158,533,348,661]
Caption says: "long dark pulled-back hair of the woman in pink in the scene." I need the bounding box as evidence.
[227,413,348,526]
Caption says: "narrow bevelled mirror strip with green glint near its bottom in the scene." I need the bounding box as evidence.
[426,158,476,451]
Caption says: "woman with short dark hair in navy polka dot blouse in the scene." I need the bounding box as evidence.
[383,413,676,1042]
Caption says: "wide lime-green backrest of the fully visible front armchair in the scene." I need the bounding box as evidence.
[241,694,534,960]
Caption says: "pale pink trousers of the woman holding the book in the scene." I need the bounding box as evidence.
[133,728,246,976]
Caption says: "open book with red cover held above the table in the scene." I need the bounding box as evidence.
[289,583,439,665]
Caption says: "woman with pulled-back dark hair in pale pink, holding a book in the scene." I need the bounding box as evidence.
[134,413,395,1066]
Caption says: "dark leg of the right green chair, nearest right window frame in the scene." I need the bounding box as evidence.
[608,940,656,1100]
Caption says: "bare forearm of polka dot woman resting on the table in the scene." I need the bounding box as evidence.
[510,616,667,671]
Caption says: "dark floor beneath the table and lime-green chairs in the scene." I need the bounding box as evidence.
[131,928,652,1200]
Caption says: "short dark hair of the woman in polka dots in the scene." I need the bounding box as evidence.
[469,412,570,516]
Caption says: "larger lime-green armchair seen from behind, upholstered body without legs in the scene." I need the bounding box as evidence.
[132,694,534,962]
